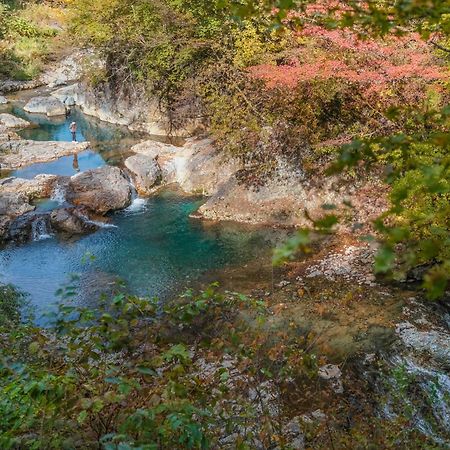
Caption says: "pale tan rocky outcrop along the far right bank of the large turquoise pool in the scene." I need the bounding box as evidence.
[127,139,352,226]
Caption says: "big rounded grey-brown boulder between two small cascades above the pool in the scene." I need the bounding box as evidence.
[66,166,131,214]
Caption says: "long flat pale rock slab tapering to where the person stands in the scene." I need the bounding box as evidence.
[0,139,89,170]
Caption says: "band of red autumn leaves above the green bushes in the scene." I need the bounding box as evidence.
[249,25,449,93]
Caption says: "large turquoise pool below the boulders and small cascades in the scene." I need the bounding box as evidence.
[0,192,273,313]
